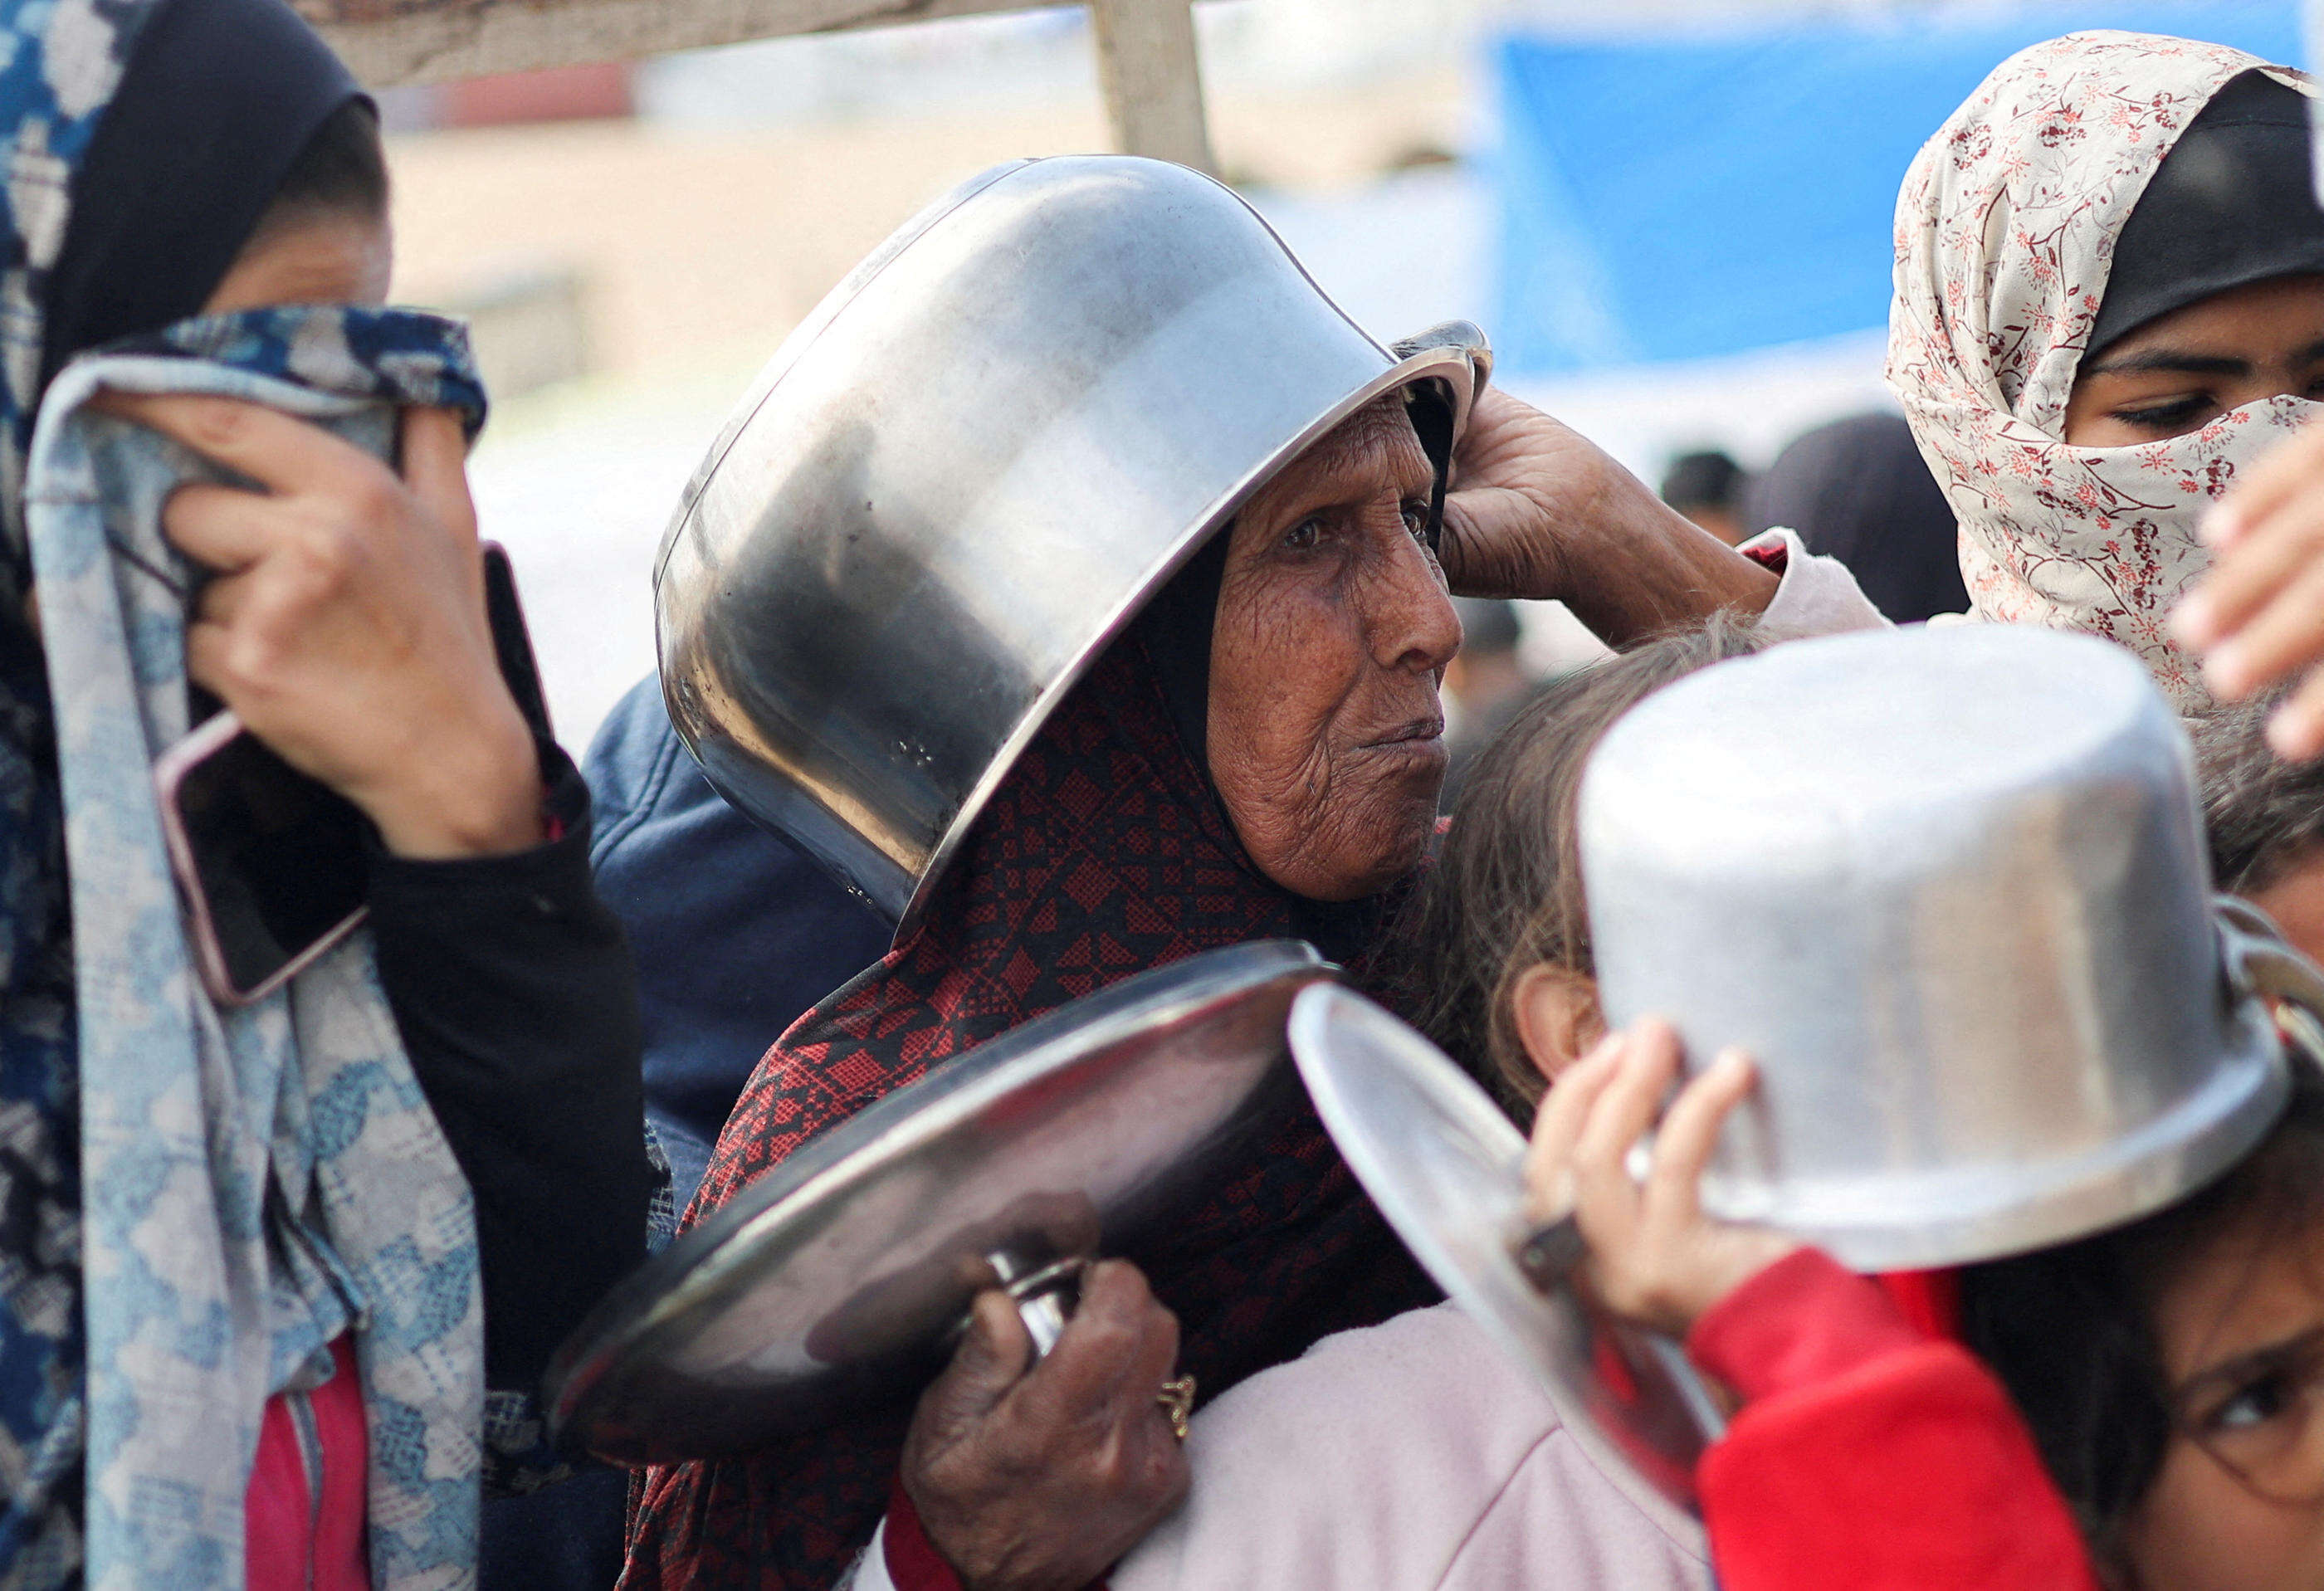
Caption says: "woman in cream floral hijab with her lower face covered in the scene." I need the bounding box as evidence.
[1887,32,2324,710]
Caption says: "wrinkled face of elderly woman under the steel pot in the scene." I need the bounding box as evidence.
[1208,398,1459,901]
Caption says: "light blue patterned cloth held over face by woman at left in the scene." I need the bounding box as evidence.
[26,309,483,1591]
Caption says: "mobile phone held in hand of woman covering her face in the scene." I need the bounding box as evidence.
[154,544,549,1006]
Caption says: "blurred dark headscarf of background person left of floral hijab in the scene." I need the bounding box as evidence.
[1745,413,1969,625]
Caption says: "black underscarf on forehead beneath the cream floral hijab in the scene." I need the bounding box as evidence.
[2089,72,2324,353]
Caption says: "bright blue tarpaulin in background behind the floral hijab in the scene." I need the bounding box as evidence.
[1494,0,2303,374]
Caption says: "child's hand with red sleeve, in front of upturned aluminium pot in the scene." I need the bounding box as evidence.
[1525,1018,1799,1338]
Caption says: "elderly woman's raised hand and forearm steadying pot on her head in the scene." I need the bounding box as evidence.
[1438,388,1775,646]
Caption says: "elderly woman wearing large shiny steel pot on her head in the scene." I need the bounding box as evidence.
[630,158,1871,1586]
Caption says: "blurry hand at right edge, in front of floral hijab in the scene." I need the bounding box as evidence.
[2170,425,2324,762]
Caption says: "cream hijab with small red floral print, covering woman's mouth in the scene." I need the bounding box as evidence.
[1887,32,2317,713]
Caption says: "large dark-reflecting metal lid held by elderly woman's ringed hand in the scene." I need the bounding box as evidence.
[546,940,1334,1463]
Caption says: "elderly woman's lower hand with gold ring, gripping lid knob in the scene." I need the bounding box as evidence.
[904,1259,1188,1591]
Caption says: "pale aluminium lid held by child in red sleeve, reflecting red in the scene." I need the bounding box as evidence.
[1290,987,1717,1551]
